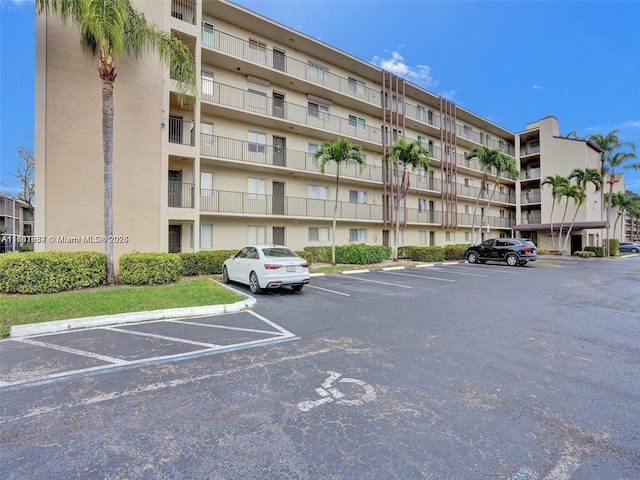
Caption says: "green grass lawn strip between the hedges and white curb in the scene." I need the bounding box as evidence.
[0,277,245,337]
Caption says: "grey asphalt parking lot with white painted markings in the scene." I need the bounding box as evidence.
[0,258,640,480]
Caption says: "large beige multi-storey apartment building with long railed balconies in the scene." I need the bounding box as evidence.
[36,0,616,266]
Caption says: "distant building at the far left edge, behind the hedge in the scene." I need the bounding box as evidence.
[0,192,34,253]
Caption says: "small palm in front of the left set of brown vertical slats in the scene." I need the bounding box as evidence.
[383,138,430,261]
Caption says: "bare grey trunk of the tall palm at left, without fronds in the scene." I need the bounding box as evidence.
[102,80,116,285]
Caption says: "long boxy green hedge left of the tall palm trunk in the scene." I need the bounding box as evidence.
[0,252,107,293]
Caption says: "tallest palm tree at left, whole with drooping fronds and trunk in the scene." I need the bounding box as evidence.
[36,0,196,285]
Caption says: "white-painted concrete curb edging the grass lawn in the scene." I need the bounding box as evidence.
[9,282,257,338]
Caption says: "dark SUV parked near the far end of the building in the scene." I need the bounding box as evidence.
[464,238,538,267]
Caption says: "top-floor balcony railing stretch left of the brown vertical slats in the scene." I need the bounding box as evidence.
[202,26,381,107]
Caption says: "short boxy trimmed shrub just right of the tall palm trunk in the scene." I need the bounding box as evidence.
[118,253,180,285]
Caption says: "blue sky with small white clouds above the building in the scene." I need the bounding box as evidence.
[0,0,640,194]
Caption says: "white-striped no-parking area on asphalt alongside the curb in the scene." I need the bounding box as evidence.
[0,311,296,388]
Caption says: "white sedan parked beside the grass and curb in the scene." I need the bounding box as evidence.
[222,245,310,293]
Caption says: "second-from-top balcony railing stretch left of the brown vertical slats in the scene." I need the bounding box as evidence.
[202,79,382,145]
